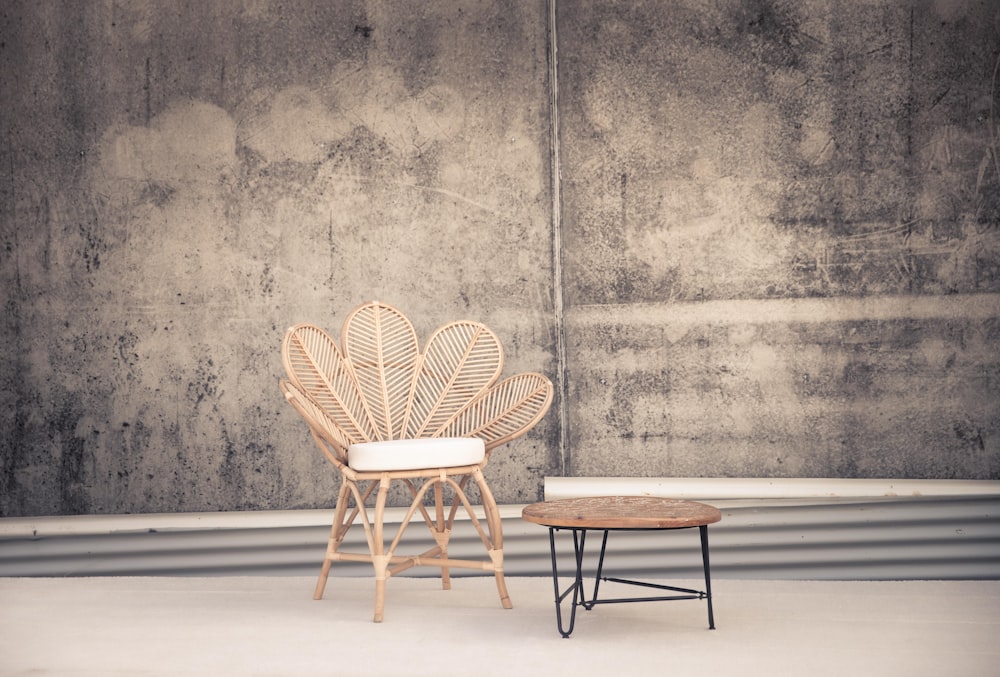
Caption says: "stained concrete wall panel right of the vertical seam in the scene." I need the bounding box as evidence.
[558,0,1000,478]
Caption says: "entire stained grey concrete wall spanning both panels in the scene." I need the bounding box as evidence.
[0,0,1000,516]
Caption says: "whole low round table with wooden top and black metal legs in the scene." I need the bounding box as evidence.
[521,496,722,637]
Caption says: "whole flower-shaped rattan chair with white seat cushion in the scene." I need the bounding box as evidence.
[280,302,552,622]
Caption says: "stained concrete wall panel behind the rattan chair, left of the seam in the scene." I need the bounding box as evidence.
[0,1,557,515]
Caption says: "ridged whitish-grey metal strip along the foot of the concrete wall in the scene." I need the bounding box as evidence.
[0,478,1000,580]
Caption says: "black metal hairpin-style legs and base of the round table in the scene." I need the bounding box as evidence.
[549,525,715,638]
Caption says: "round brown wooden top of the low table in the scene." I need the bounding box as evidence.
[521,496,722,529]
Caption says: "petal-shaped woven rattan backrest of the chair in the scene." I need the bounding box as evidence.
[282,302,552,449]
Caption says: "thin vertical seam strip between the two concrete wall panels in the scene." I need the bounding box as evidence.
[548,0,569,475]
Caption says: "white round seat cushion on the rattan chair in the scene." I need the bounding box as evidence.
[347,437,486,472]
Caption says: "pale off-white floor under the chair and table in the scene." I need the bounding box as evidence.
[0,577,1000,677]
